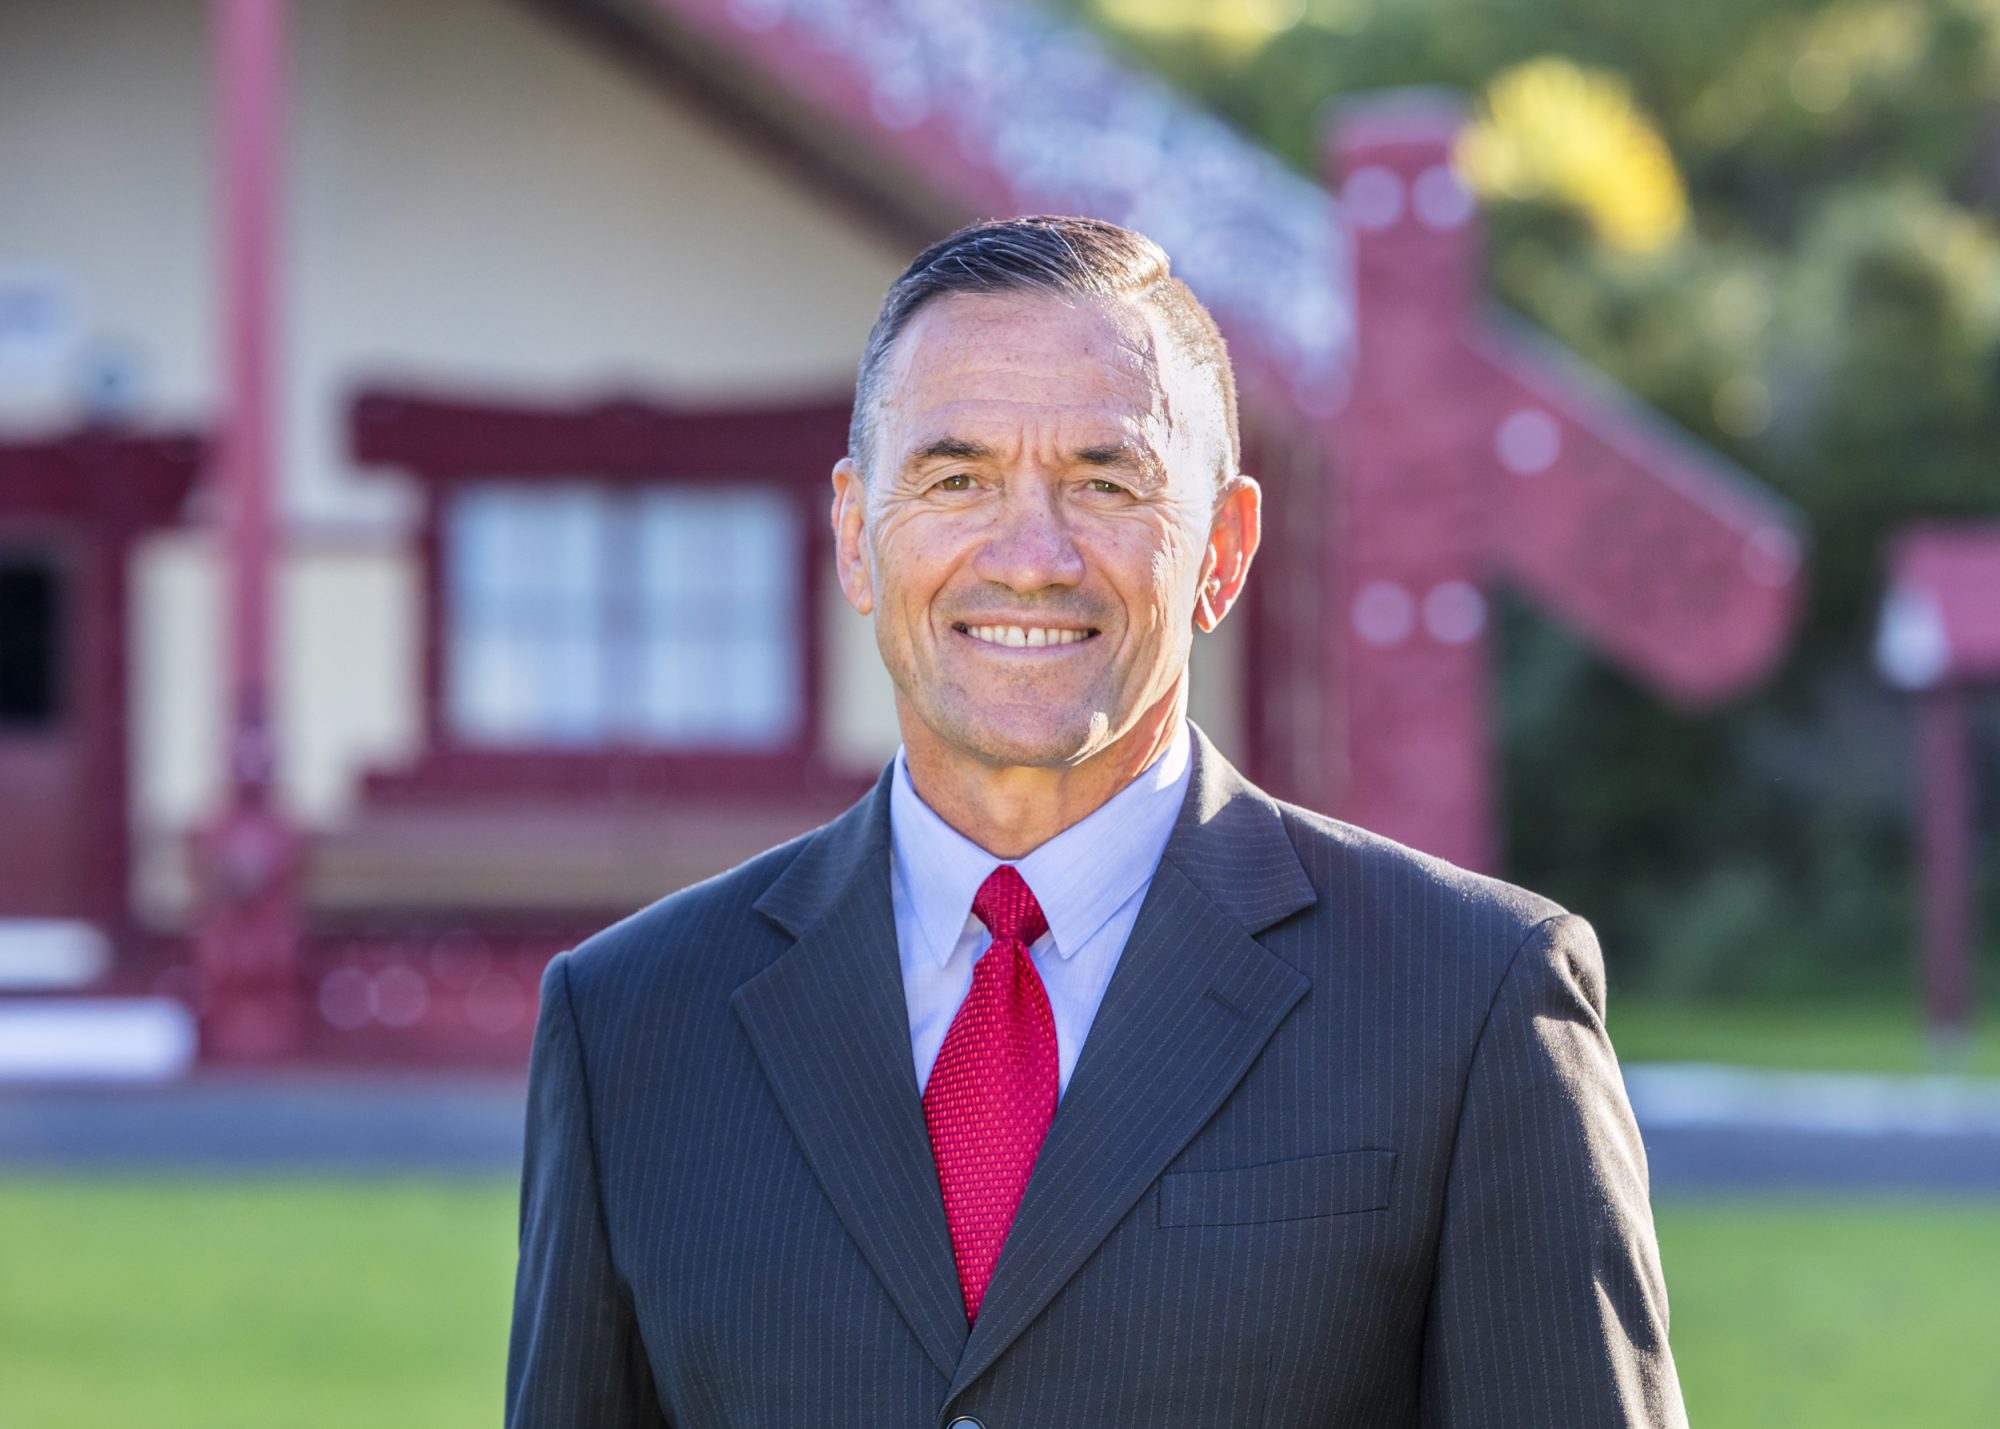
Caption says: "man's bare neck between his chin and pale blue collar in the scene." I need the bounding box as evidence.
[902,674,1188,859]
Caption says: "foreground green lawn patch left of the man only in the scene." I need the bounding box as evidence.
[0,1179,516,1429]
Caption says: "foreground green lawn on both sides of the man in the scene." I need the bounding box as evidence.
[0,1177,2000,1429]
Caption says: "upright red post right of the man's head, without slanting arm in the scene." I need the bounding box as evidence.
[1326,94,1498,869]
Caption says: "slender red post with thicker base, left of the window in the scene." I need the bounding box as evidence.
[196,0,302,1061]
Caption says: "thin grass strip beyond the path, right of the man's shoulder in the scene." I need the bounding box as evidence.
[1608,989,2000,1077]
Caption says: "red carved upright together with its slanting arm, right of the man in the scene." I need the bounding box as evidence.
[1326,92,1802,871]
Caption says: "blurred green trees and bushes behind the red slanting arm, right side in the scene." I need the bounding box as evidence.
[1072,0,2000,997]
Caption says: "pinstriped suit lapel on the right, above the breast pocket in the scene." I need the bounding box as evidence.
[948,731,1314,1397]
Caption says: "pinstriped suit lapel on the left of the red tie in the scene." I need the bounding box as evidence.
[732,773,966,1377]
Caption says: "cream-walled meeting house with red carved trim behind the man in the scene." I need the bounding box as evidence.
[0,0,1800,1075]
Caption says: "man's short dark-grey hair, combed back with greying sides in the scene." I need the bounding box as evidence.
[848,214,1242,486]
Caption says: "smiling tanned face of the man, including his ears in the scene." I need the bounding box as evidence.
[834,294,1256,767]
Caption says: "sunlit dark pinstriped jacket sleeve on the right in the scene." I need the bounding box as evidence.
[1420,913,1686,1429]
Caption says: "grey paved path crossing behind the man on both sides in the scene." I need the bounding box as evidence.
[0,1067,2000,1197]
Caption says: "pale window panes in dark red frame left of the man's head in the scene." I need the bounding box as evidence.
[444,480,806,753]
